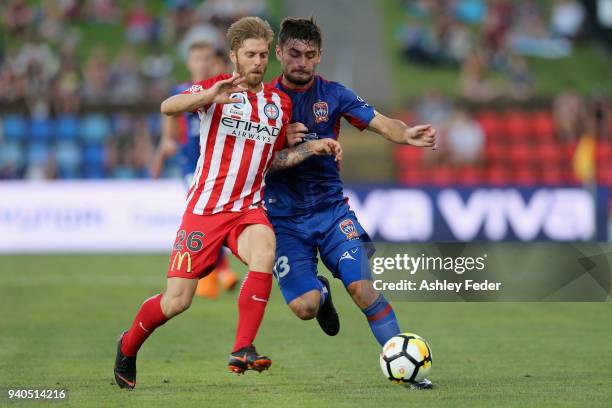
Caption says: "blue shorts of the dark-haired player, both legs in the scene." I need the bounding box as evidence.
[270,201,374,303]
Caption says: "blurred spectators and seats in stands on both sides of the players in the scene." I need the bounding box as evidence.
[0,0,612,182]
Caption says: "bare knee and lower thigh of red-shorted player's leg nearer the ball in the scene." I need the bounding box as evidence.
[236,224,276,272]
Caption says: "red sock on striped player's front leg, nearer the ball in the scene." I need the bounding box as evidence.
[232,271,272,352]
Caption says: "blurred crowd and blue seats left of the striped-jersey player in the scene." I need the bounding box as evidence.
[0,0,266,179]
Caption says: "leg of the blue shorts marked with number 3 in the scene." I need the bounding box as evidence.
[274,231,320,304]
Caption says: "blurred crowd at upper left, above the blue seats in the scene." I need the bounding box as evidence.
[0,0,265,111]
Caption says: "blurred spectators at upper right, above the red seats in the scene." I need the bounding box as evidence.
[398,0,585,102]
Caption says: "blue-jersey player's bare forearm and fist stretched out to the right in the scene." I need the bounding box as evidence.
[368,113,437,150]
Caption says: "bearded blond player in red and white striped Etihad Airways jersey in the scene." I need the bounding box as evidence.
[114,17,342,389]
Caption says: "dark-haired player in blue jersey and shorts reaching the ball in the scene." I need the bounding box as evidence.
[265,18,436,388]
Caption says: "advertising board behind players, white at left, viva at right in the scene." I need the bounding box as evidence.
[0,180,608,253]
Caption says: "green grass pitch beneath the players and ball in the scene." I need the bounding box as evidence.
[0,255,612,408]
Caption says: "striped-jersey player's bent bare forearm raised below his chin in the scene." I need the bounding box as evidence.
[161,74,244,115]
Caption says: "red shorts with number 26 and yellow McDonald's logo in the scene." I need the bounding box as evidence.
[168,208,272,279]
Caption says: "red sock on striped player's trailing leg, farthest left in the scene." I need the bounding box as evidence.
[121,293,168,356]
